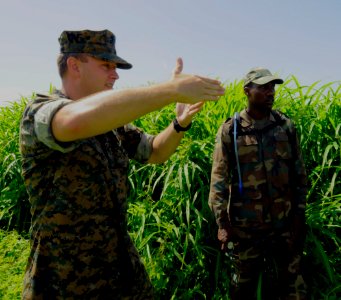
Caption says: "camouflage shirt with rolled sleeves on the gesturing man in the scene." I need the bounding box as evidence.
[20,92,153,299]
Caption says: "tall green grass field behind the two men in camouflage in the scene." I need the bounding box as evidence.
[0,77,341,300]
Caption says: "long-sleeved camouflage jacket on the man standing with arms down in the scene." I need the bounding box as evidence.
[209,110,307,230]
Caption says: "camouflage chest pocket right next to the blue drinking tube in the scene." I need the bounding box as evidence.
[233,135,259,163]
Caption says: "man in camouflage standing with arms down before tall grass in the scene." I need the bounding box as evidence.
[209,68,307,300]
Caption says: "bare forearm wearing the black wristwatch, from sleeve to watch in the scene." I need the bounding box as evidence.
[148,124,184,164]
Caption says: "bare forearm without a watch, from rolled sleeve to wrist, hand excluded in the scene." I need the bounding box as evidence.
[52,83,175,142]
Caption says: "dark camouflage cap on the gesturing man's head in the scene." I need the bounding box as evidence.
[58,30,132,69]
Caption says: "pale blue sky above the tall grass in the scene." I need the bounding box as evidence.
[0,0,341,105]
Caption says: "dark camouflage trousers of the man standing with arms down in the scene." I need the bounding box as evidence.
[226,232,307,300]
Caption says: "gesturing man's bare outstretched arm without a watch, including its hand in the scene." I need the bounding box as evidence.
[52,59,224,142]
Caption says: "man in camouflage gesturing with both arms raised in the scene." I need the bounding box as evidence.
[20,30,224,299]
